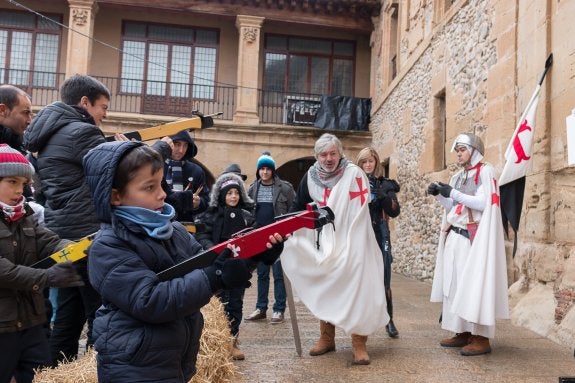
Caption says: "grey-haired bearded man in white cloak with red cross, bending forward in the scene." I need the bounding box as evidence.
[281,133,389,364]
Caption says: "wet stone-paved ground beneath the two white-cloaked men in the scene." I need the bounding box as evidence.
[234,275,575,383]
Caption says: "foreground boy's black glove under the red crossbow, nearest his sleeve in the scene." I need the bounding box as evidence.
[204,248,252,292]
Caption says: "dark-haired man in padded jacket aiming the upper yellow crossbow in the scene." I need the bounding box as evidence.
[24,75,169,365]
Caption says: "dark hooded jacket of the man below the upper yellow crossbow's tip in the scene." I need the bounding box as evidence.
[162,130,210,222]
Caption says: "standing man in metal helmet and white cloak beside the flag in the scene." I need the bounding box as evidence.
[427,133,509,356]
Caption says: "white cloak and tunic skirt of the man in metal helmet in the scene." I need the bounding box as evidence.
[431,164,509,335]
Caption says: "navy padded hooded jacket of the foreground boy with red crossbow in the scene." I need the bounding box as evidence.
[84,142,212,383]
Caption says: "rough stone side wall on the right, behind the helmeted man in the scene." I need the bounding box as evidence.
[370,0,575,346]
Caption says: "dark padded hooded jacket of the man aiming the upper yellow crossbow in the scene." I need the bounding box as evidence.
[24,101,105,240]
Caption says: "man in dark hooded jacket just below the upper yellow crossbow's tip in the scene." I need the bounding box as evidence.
[162,130,210,222]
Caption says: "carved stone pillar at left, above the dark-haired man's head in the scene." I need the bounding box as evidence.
[66,0,98,78]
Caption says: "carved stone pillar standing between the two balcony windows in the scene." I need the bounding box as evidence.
[233,15,264,124]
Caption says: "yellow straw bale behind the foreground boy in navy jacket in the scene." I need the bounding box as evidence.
[34,297,238,383]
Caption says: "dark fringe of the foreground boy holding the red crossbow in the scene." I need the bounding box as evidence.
[112,145,164,194]
